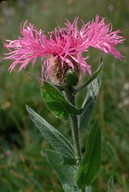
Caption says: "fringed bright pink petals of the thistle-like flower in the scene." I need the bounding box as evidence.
[4,16,124,79]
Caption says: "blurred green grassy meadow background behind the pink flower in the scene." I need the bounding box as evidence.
[0,0,129,192]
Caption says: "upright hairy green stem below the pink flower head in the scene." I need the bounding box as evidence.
[65,87,81,164]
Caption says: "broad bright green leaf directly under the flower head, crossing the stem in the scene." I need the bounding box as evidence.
[41,82,82,121]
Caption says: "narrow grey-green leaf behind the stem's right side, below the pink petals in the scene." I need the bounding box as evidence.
[79,70,101,131]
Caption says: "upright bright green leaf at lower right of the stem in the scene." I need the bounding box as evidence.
[77,122,101,188]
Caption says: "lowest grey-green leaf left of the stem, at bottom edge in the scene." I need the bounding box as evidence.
[47,150,80,192]
